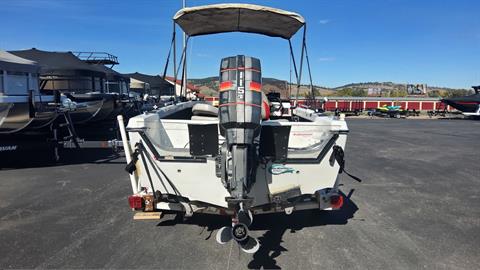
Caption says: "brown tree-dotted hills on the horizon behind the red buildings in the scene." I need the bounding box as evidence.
[189,76,473,97]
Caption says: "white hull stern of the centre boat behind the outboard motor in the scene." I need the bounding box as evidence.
[127,104,348,213]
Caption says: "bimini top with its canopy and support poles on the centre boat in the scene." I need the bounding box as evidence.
[163,4,315,105]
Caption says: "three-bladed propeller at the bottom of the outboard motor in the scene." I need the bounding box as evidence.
[215,210,260,253]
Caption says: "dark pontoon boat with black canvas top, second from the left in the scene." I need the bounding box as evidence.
[10,48,116,124]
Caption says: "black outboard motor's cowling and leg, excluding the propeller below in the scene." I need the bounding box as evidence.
[219,55,262,199]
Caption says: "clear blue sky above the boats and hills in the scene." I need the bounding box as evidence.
[0,0,480,89]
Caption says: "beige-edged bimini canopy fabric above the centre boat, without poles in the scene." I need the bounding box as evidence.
[173,4,305,39]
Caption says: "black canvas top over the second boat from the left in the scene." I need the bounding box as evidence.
[10,48,105,77]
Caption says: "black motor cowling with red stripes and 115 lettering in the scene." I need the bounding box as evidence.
[219,55,262,146]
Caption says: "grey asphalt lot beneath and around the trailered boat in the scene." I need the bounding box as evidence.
[0,119,480,269]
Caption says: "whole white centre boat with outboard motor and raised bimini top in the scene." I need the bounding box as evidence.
[119,4,349,253]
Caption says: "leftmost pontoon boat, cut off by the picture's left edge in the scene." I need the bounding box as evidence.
[0,51,57,134]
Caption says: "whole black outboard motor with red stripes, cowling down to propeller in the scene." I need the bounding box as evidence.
[217,55,262,253]
